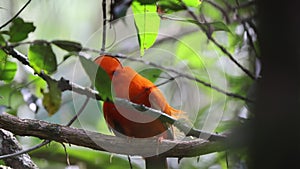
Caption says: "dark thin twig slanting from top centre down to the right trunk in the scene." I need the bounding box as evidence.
[180,0,256,80]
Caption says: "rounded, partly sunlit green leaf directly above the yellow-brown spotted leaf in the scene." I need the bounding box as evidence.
[28,41,57,74]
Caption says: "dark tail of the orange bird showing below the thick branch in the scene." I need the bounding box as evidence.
[145,156,168,169]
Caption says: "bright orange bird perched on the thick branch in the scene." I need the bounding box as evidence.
[95,55,181,168]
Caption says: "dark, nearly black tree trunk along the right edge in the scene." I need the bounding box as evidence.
[249,0,300,169]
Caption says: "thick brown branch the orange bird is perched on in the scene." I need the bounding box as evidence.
[0,113,228,157]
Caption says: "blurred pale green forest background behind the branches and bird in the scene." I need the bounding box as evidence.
[0,0,258,169]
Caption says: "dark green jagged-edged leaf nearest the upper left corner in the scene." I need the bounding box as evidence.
[9,18,35,42]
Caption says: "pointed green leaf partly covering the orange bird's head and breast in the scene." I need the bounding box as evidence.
[79,57,112,100]
